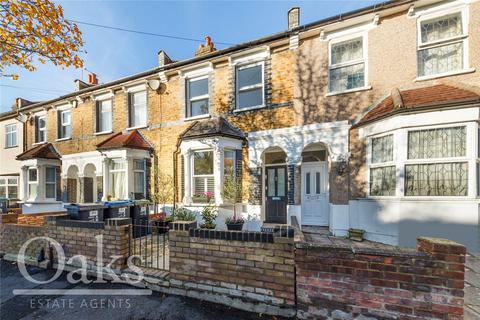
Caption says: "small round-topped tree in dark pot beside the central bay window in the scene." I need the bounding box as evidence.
[222,173,245,231]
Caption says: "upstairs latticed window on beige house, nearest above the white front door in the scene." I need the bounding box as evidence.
[328,37,365,93]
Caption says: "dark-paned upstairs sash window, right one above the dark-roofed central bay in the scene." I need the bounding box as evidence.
[236,62,264,110]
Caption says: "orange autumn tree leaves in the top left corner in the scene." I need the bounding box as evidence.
[0,0,83,79]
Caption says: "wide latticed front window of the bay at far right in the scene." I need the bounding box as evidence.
[405,126,468,196]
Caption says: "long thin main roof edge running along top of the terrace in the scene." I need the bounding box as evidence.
[17,0,417,110]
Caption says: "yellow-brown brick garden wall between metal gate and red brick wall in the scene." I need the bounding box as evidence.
[169,222,295,316]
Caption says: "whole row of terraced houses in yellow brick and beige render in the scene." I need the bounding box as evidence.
[7,0,480,251]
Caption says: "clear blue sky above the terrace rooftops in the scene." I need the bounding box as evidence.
[0,0,379,112]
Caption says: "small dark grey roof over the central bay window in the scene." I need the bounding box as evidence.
[180,117,245,140]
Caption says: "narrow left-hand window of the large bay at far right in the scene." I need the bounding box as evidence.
[370,134,396,196]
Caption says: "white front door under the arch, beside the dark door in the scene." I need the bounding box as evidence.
[301,162,329,226]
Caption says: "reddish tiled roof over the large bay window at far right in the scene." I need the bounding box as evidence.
[356,84,480,126]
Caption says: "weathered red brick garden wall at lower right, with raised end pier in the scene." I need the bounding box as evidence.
[295,238,465,319]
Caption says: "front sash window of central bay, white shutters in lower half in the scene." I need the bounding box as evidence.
[192,150,215,202]
